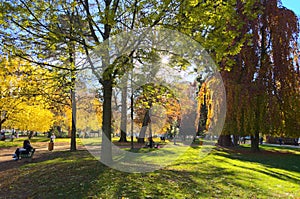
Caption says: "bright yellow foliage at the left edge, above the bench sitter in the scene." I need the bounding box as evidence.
[0,57,60,132]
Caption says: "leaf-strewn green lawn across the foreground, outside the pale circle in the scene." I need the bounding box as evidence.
[0,146,300,199]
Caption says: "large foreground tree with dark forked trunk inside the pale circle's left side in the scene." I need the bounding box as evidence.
[80,0,183,162]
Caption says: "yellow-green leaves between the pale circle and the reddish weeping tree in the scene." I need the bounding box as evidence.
[175,0,260,70]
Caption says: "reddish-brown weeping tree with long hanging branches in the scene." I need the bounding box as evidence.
[219,0,300,151]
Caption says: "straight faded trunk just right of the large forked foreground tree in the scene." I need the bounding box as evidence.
[119,77,128,142]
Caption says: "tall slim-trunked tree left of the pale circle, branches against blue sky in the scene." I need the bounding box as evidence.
[1,0,89,150]
